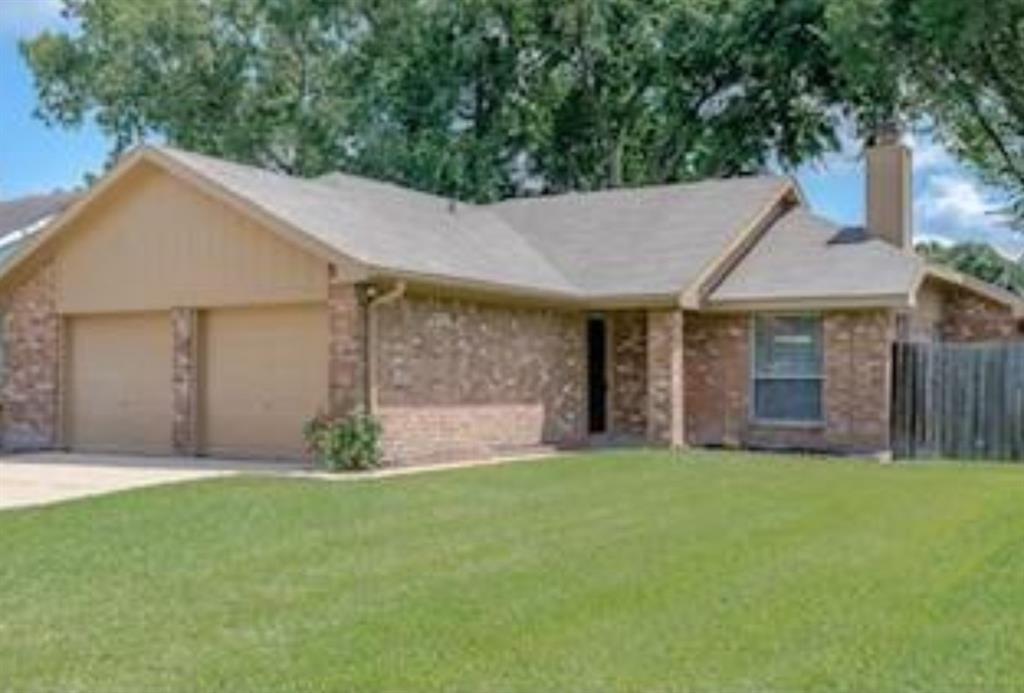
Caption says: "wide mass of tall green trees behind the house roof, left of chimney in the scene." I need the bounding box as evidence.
[22,0,860,201]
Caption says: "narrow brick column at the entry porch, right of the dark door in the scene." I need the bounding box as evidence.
[647,308,686,447]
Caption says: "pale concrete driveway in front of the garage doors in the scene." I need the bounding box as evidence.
[0,452,302,510]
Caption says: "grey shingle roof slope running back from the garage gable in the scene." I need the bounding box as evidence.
[161,148,575,294]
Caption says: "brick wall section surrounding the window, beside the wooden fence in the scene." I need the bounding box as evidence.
[684,310,895,452]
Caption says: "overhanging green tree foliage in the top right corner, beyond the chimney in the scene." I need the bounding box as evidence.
[829,0,1024,225]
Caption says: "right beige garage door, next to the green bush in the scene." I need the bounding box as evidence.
[200,306,328,458]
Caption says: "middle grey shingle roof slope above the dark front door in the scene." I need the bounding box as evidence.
[493,176,792,296]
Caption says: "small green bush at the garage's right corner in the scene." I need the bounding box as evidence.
[304,412,381,472]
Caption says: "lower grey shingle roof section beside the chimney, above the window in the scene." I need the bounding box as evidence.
[710,208,925,306]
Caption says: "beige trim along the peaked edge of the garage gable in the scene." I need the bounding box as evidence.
[0,147,367,289]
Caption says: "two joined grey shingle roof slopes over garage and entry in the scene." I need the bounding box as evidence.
[161,147,792,298]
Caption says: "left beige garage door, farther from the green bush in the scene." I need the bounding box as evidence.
[67,313,173,453]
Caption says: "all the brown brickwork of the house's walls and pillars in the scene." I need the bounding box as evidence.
[0,257,1020,462]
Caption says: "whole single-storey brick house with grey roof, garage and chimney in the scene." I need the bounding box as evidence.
[0,133,1024,463]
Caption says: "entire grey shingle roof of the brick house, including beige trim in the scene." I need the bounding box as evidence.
[0,147,1024,314]
